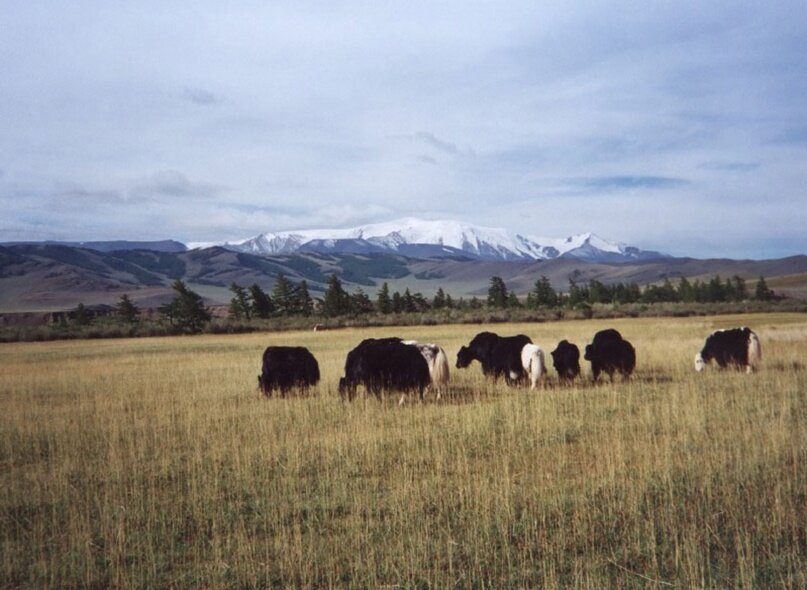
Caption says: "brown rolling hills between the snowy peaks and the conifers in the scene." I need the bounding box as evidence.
[0,244,807,312]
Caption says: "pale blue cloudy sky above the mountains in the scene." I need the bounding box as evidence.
[0,0,807,258]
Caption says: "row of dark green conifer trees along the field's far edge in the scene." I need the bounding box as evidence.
[96,273,776,333]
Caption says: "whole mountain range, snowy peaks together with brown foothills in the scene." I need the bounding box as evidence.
[0,218,807,321]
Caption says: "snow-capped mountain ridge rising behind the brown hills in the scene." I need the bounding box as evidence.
[223,218,667,262]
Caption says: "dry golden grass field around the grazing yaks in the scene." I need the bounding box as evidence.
[0,314,807,588]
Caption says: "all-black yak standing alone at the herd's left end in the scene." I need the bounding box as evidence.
[258,346,319,397]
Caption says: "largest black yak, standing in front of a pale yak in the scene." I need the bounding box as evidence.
[339,338,431,403]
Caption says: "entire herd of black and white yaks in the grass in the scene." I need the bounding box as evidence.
[258,328,762,401]
